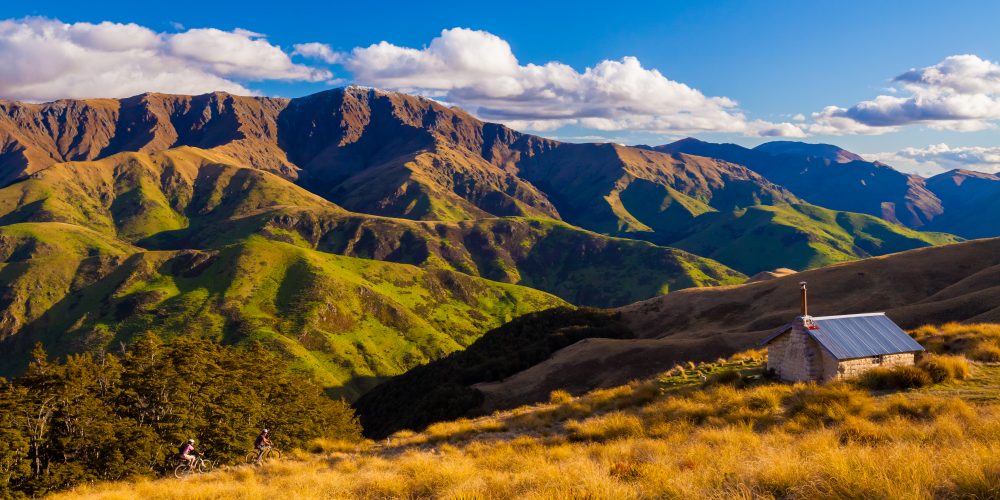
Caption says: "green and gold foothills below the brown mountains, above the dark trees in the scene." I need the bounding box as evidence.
[0,147,744,398]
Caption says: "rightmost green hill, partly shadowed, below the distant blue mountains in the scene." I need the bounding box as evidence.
[672,204,961,274]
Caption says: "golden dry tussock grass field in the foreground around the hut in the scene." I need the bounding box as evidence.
[52,325,1000,500]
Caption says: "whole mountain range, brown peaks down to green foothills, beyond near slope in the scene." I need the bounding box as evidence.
[0,87,1000,398]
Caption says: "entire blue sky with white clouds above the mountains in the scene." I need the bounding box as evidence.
[0,0,1000,175]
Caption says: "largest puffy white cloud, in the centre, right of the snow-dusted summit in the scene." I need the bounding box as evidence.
[340,28,803,137]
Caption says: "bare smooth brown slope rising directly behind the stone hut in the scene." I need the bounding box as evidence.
[477,238,1000,408]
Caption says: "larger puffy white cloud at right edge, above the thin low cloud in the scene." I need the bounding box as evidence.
[808,54,1000,134]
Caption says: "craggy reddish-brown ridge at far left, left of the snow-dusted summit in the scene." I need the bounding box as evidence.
[0,92,295,184]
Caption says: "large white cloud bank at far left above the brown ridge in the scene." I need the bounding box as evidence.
[0,18,332,101]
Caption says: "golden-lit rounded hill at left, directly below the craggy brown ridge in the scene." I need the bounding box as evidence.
[0,147,338,242]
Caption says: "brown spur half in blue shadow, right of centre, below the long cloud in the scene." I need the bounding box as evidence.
[519,144,796,241]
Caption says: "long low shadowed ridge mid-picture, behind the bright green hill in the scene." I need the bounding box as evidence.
[142,207,746,307]
